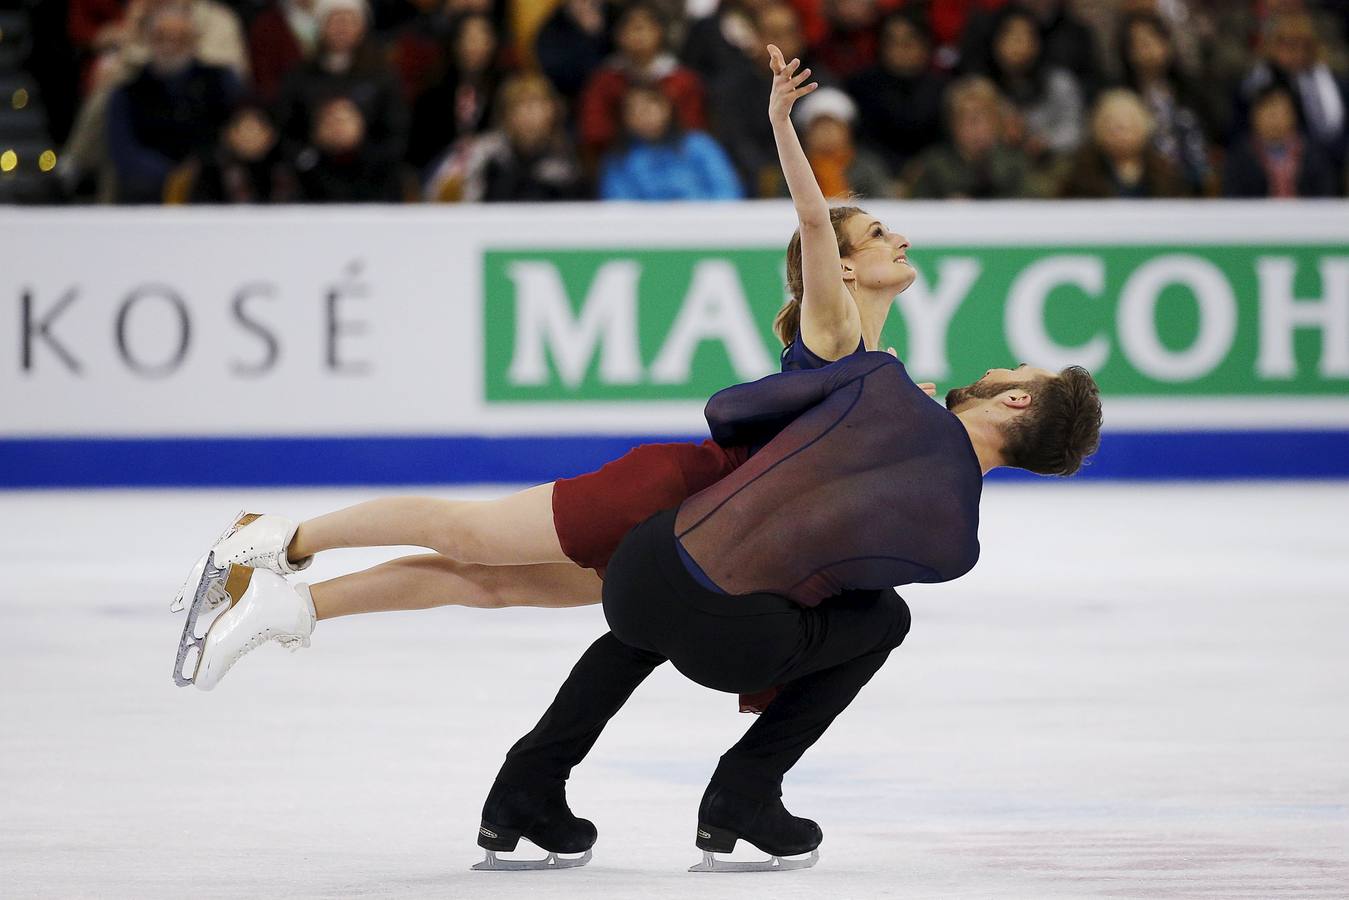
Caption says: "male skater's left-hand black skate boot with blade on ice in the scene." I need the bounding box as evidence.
[473,781,598,870]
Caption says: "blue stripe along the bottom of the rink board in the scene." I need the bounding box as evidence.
[0,430,1349,488]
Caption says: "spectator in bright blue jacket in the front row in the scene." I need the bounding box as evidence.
[599,85,745,200]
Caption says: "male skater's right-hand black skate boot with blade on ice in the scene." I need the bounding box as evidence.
[689,784,824,872]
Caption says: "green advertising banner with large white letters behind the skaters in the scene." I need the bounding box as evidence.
[483,244,1349,403]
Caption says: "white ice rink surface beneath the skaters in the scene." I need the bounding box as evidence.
[0,484,1349,900]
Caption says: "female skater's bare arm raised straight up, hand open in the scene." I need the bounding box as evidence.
[768,45,862,359]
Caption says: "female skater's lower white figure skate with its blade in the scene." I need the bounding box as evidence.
[173,564,316,691]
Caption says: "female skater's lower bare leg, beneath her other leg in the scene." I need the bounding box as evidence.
[309,553,603,619]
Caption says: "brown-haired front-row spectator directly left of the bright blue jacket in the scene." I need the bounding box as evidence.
[425,74,587,202]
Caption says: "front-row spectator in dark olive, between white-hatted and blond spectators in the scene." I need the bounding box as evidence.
[904,76,1031,200]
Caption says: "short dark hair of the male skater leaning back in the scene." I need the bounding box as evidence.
[1002,366,1101,476]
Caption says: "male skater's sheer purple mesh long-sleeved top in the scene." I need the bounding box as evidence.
[675,352,983,606]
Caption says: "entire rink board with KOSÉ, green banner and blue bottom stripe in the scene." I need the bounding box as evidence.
[0,201,1349,487]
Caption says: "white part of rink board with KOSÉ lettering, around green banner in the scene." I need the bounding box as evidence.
[0,201,1349,437]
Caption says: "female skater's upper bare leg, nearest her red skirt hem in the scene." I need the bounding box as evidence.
[287,482,575,568]
